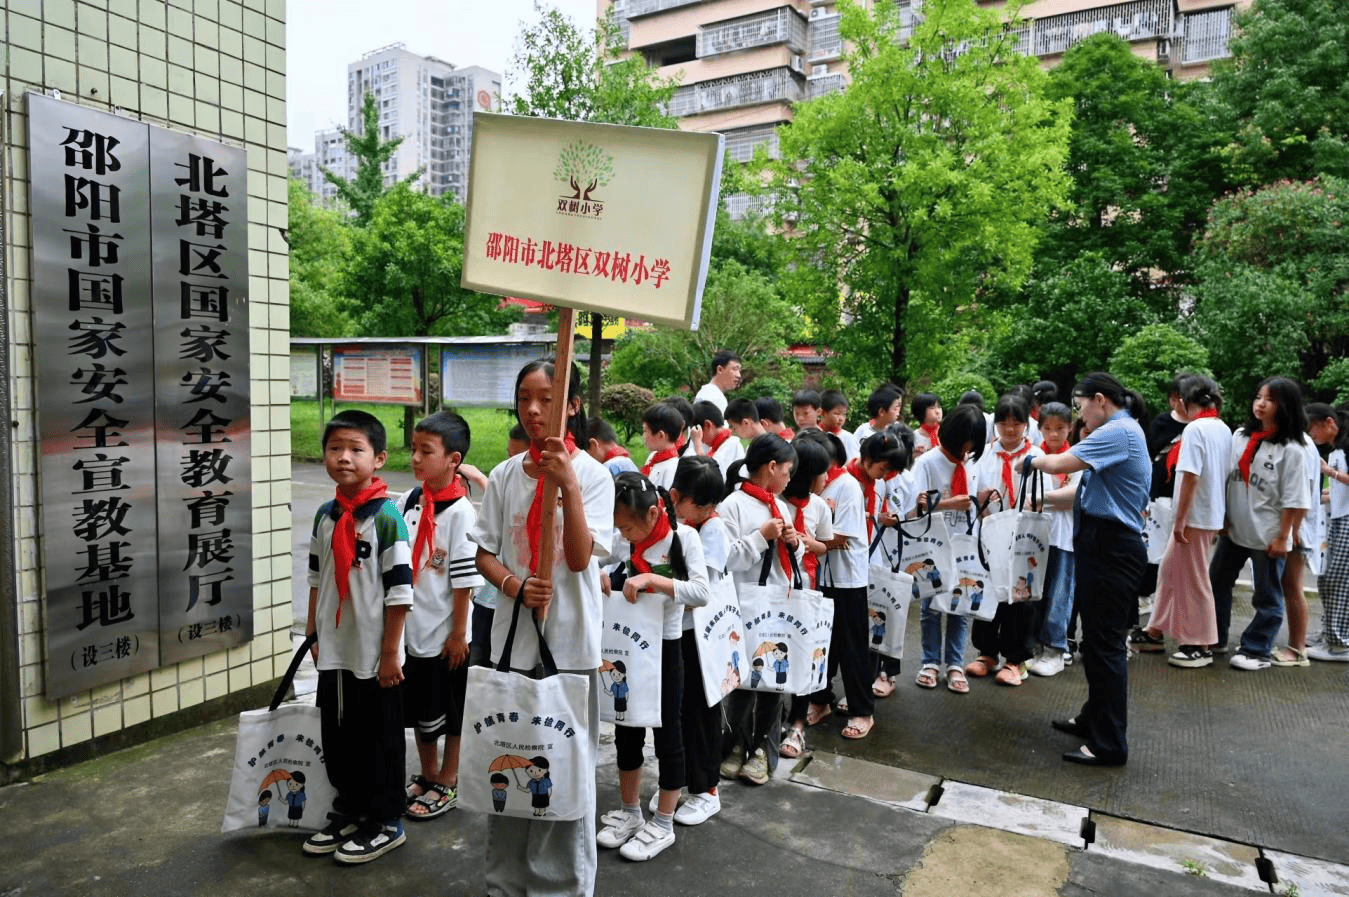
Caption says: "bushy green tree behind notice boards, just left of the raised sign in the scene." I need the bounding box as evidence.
[341,183,515,336]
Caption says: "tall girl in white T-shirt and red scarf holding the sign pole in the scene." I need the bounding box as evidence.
[469,360,614,894]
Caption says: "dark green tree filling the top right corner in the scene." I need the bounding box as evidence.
[1213,0,1349,185]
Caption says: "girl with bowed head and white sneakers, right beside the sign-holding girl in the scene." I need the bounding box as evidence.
[595,472,710,862]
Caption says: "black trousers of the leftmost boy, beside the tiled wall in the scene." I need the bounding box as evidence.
[316,669,407,823]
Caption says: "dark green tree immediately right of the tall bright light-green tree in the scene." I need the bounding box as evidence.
[1036,31,1224,299]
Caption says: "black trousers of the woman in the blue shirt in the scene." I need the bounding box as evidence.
[1072,514,1148,763]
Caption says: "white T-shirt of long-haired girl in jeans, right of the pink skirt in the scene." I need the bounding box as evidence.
[1224,429,1311,550]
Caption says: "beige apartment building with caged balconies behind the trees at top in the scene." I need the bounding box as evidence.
[598,0,1249,214]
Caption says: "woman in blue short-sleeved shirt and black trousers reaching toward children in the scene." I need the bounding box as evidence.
[1027,372,1152,766]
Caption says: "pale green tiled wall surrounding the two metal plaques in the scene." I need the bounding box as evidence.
[0,0,291,758]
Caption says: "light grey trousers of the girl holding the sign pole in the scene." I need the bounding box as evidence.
[487,669,599,897]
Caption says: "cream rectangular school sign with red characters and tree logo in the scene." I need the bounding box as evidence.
[463,112,723,329]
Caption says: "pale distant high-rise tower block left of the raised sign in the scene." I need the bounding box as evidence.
[291,43,502,202]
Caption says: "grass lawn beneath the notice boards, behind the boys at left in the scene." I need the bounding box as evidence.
[290,399,646,473]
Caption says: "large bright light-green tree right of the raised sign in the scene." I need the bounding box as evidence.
[769,0,1070,384]
